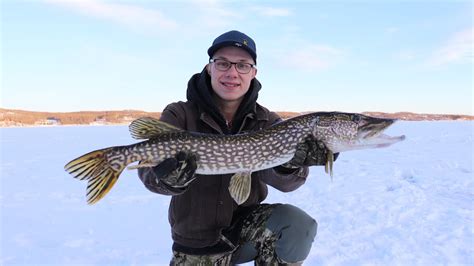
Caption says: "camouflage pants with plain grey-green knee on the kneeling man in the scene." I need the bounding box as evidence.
[171,204,317,266]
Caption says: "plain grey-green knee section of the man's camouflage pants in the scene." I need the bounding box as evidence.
[266,204,318,262]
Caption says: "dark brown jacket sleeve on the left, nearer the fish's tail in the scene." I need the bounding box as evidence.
[138,104,186,195]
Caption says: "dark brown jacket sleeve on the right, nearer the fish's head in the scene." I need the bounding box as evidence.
[255,112,309,192]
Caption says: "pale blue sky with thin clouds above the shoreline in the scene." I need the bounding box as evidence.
[0,0,474,115]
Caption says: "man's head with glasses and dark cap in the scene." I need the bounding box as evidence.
[206,31,257,104]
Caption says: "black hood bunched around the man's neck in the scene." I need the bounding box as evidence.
[186,68,262,133]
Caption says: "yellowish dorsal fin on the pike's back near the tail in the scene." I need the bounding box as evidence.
[128,117,182,139]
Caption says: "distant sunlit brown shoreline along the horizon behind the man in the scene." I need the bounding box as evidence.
[0,108,474,127]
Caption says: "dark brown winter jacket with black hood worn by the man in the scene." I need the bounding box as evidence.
[138,68,308,248]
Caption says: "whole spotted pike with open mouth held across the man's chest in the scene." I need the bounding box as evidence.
[64,112,405,205]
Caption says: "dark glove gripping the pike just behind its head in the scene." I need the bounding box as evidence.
[275,135,339,174]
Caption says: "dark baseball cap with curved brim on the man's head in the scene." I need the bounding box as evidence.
[207,30,257,64]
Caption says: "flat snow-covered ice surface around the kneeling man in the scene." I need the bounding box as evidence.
[0,121,474,265]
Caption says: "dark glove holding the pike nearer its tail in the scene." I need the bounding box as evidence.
[152,151,197,192]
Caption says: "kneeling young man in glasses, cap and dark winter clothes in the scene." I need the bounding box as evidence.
[139,31,336,265]
